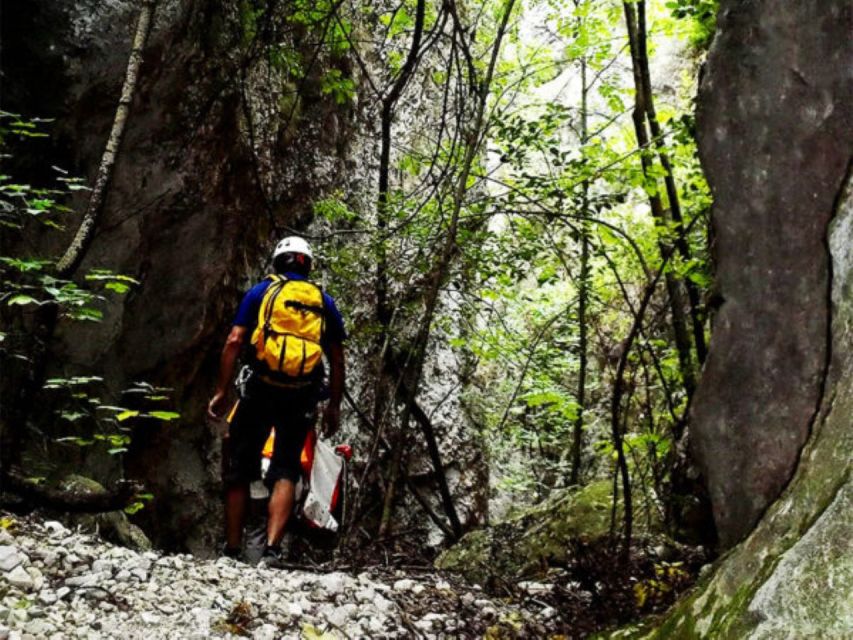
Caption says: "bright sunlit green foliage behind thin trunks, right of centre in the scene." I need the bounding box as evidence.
[412,1,715,509]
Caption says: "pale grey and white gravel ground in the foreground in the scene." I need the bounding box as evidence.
[0,513,555,640]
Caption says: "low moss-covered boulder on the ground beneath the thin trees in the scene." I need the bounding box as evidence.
[435,480,658,585]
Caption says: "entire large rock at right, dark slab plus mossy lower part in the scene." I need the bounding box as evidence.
[653,1,853,639]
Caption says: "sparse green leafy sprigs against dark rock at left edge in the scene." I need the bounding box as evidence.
[0,112,180,513]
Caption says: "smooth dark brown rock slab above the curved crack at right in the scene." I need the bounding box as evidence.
[690,0,853,548]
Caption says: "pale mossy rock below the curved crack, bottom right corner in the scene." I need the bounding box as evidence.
[644,168,853,640]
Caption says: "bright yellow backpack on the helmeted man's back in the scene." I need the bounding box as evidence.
[252,275,326,383]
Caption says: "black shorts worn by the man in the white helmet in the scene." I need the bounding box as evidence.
[223,380,318,487]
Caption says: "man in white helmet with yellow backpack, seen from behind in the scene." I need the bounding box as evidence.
[208,236,346,564]
